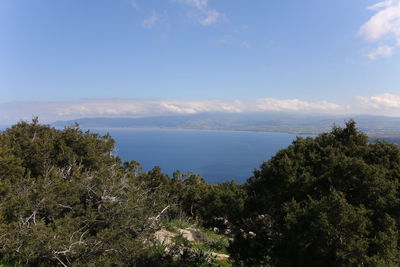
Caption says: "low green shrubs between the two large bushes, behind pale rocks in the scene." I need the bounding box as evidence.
[134,166,246,227]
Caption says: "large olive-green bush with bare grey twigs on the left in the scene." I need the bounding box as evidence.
[0,120,171,266]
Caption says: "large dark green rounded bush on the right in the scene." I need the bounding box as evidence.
[230,121,400,266]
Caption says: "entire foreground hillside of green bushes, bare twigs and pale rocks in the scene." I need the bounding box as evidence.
[0,119,400,266]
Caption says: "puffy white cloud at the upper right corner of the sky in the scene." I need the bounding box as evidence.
[359,0,400,60]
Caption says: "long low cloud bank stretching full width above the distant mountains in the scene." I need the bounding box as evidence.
[0,93,400,123]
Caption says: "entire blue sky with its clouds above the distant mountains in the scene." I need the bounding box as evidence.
[0,0,400,123]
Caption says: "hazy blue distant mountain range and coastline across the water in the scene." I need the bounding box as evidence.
[52,113,400,138]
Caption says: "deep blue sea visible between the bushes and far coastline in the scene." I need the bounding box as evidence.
[91,129,296,183]
